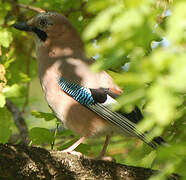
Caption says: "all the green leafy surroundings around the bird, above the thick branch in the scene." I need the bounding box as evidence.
[0,0,186,180]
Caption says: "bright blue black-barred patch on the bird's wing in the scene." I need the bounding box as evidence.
[58,78,95,105]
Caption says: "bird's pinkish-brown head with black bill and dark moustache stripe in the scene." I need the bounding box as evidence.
[13,12,83,56]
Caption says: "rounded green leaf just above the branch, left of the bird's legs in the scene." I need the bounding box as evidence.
[29,127,54,144]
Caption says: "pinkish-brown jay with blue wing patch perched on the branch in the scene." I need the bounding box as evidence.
[14,12,163,156]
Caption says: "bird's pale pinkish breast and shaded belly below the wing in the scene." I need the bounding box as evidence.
[40,62,111,136]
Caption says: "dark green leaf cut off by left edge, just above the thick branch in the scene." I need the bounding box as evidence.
[0,108,12,143]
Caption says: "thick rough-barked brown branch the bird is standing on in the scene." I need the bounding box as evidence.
[0,144,178,180]
